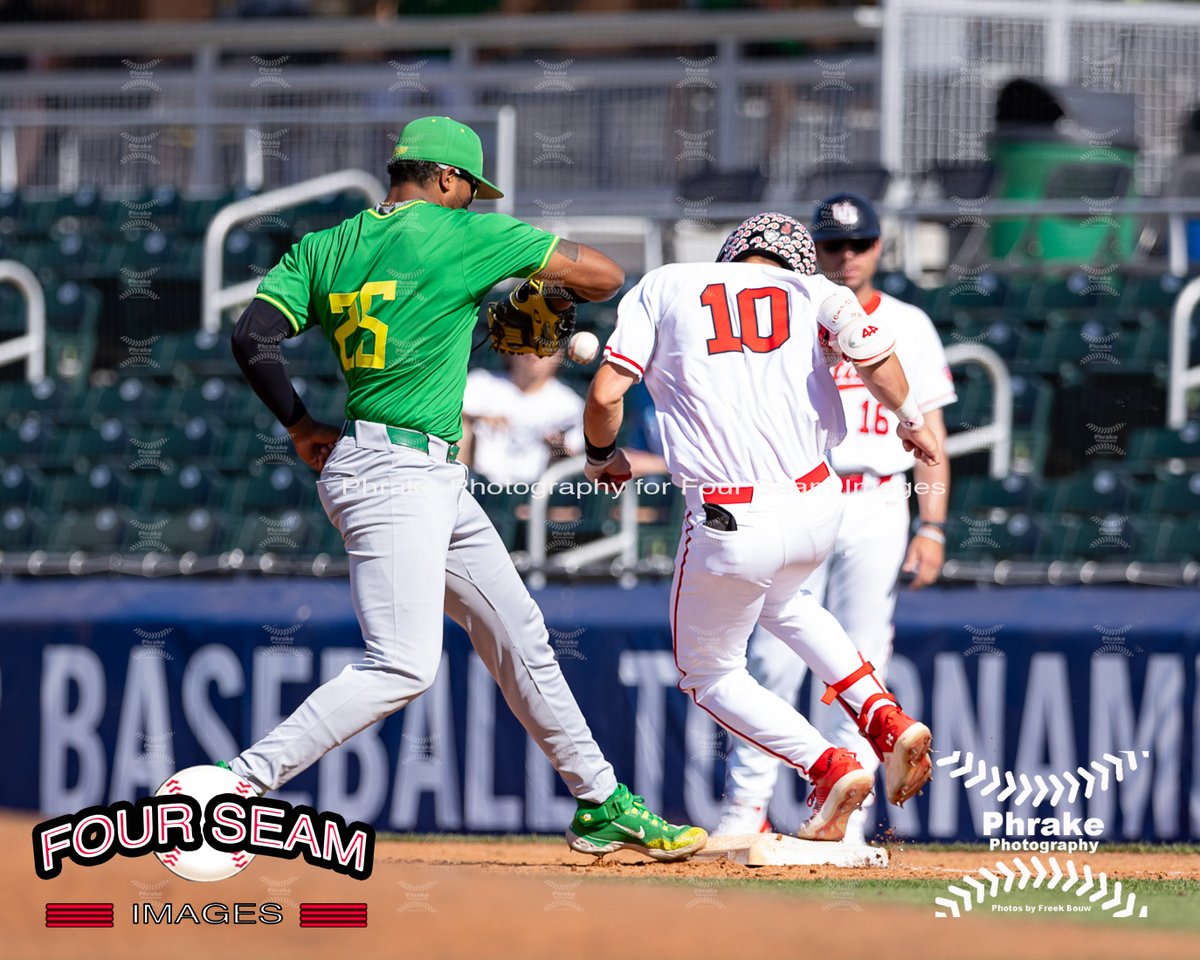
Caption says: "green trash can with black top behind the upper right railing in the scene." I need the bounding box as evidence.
[991,79,1138,265]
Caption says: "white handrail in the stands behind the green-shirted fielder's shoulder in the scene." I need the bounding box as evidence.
[200,170,388,334]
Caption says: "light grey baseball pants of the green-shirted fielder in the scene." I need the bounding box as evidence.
[230,420,617,803]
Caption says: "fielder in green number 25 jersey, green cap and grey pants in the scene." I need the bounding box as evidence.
[228,116,707,860]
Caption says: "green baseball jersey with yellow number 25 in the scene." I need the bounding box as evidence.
[256,200,558,443]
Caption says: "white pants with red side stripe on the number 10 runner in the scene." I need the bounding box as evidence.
[671,475,883,775]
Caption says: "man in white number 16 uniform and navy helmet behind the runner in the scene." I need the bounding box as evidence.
[716,193,956,844]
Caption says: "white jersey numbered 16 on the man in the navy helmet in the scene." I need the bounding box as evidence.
[829,294,958,476]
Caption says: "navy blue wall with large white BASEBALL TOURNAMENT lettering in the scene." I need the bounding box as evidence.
[0,578,1200,841]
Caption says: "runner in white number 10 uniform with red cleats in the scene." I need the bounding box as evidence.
[583,214,941,840]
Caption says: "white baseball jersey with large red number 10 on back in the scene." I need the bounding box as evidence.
[605,263,865,487]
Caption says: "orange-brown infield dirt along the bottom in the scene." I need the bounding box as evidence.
[0,814,1200,960]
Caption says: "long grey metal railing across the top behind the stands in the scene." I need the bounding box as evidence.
[0,8,880,204]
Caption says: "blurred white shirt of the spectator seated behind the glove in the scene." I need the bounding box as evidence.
[462,370,583,484]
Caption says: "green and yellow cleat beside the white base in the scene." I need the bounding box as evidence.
[566,784,708,863]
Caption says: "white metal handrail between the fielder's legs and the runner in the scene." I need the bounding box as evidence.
[527,457,637,589]
